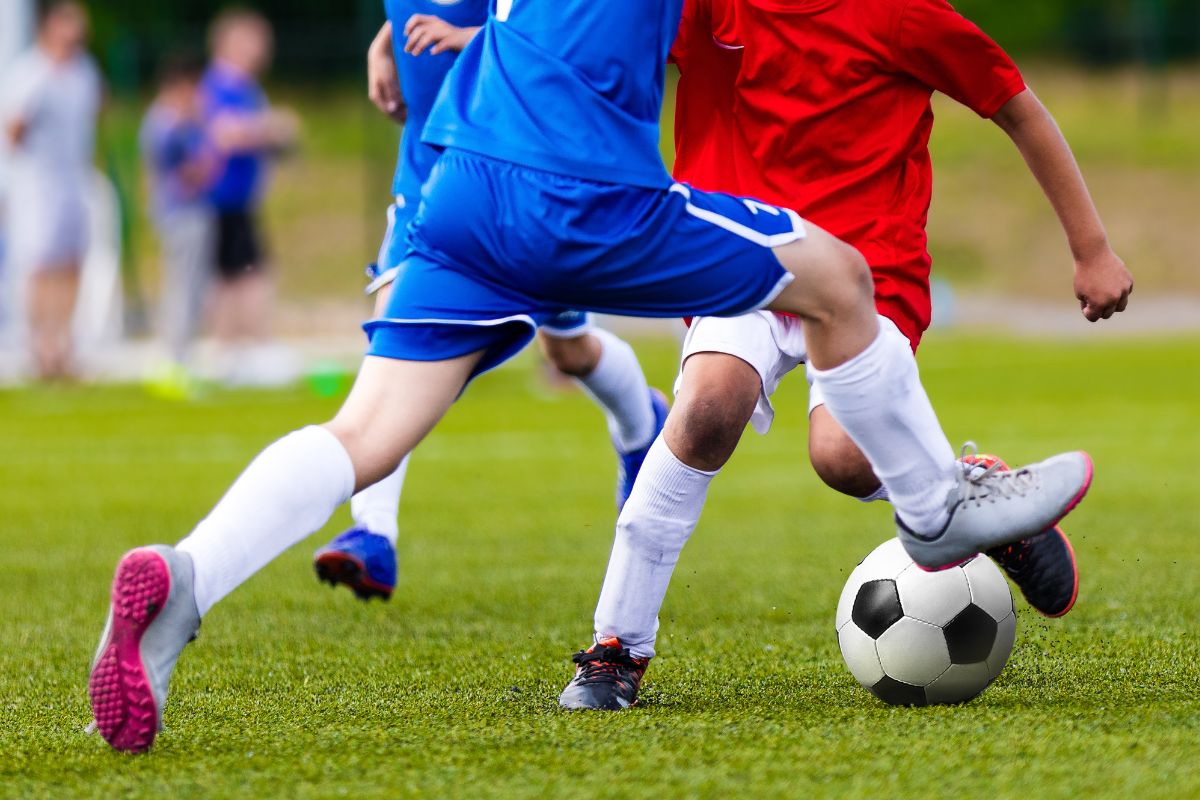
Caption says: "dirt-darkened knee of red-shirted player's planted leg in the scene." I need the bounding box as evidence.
[666,356,762,471]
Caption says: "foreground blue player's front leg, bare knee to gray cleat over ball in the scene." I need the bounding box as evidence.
[770,227,1092,569]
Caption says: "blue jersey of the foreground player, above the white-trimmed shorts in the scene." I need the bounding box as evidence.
[424,0,683,188]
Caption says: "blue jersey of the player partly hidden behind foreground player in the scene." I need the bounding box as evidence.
[384,0,488,201]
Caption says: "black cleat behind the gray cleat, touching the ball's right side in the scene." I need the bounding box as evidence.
[962,455,1079,618]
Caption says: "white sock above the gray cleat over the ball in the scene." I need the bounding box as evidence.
[811,325,955,533]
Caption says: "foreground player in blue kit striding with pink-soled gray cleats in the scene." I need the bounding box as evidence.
[89,0,1092,751]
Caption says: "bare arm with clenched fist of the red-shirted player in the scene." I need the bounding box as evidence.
[992,89,1133,323]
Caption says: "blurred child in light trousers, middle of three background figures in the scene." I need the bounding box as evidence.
[140,54,216,395]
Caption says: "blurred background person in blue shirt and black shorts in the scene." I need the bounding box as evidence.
[200,10,299,385]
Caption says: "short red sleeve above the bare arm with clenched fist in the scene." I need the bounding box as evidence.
[894,0,1025,119]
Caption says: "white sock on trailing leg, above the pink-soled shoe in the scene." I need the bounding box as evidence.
[178,426,354,615]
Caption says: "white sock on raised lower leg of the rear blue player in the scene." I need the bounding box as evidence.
[578,327,654,453]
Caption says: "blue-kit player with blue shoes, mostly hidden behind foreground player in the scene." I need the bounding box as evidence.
[314,0,667,600]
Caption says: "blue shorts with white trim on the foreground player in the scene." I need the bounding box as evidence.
[364,150,804,373]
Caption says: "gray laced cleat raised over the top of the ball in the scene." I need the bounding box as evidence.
[896,445,1092,571]
